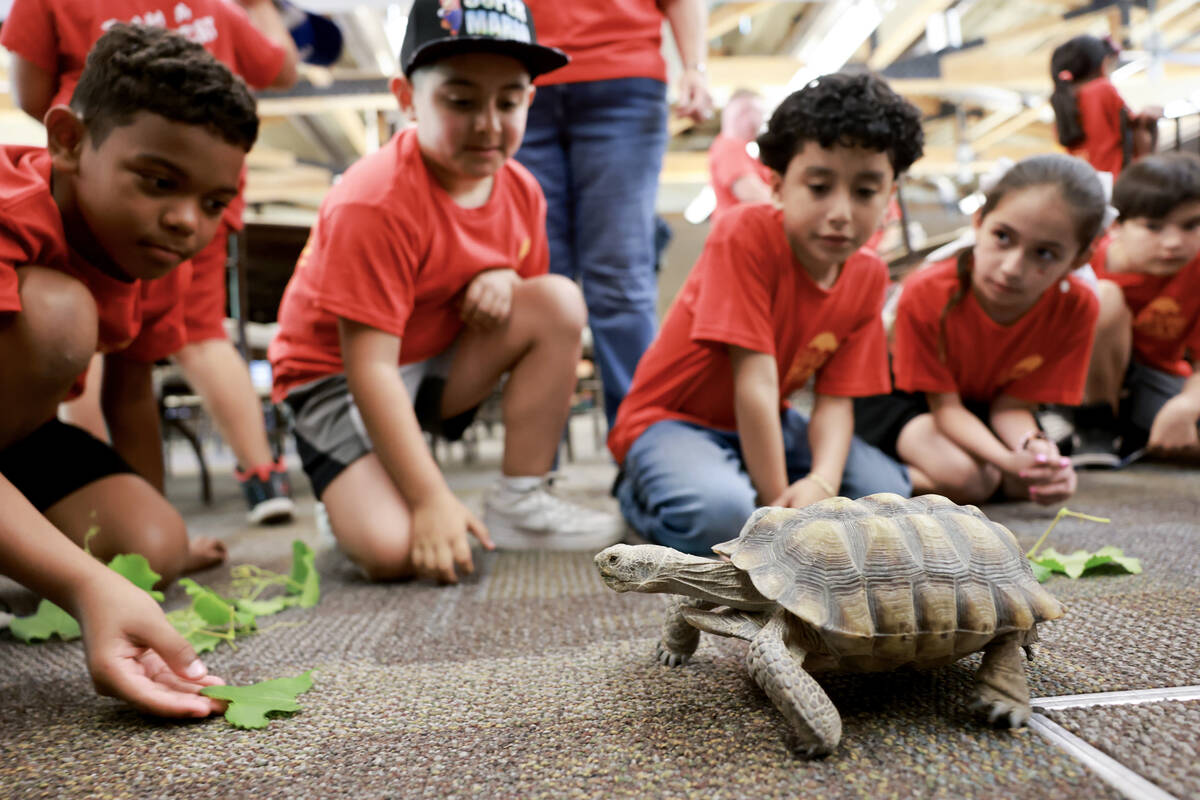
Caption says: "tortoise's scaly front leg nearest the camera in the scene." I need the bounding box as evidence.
[746,615,841,758]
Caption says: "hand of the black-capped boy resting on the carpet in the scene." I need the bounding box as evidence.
[412,491,496,583]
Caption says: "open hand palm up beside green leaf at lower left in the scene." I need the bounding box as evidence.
[71,569,224,717]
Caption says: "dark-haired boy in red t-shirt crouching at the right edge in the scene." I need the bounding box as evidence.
[1072,152,1200,467]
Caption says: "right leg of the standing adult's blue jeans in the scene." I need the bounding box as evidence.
[566,78,667,428]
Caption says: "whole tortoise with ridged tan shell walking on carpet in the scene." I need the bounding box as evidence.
[595,493,1063,757]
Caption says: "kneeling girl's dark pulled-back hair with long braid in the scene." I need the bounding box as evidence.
[937,152,1108,361]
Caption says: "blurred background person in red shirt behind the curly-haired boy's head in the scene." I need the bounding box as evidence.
[708,89,770,215]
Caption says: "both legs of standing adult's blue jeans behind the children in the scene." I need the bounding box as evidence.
[516,78,667,428]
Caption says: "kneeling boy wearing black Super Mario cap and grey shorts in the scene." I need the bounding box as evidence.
[270,0,624,582]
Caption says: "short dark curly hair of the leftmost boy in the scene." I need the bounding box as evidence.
[71,23,258,152]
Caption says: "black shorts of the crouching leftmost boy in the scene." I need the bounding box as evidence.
[0,420,136,511]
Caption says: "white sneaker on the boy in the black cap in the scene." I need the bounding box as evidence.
[484,480,625,551]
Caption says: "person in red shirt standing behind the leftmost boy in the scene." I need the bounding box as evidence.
[0,0,298,523]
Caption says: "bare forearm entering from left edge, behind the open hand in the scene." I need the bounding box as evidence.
[0,475,102,612]
